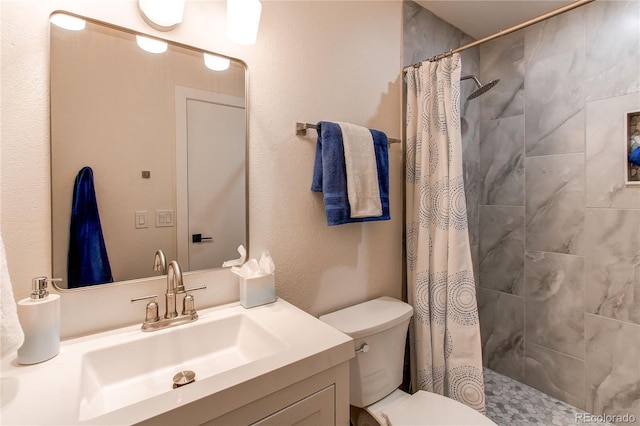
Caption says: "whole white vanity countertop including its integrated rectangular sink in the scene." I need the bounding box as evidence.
[0,299,354,426]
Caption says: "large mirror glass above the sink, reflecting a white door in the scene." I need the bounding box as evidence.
[50,12,248,288]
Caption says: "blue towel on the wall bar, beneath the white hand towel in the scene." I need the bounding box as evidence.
[311,121,391,226]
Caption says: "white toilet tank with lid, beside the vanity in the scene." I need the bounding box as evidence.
[320,296,413,408]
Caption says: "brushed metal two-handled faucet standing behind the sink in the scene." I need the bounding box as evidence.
[131,255,207,331]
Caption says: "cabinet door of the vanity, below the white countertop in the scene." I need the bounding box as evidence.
[254,385,335,426]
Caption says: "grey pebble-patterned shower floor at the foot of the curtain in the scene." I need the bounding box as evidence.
[484,368,610,426]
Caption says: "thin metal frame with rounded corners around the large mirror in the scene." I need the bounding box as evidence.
[48,10,250,293]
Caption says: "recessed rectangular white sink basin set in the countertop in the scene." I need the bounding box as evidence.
[79,314,286,421]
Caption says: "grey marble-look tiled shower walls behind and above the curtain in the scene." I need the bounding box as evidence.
[403,1,640,423]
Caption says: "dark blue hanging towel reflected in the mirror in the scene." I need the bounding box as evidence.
[67,167,113,288]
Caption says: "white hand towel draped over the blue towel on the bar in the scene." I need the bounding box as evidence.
[338,123,382,218]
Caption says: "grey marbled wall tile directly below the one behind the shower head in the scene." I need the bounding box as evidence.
[480,115,524,206]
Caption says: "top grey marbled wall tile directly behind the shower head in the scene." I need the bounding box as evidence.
[478,31,525,121]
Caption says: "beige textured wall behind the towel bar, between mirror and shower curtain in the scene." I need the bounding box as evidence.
[244,1,403,314]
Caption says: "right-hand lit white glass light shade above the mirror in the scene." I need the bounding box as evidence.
[227,0,262,44]
